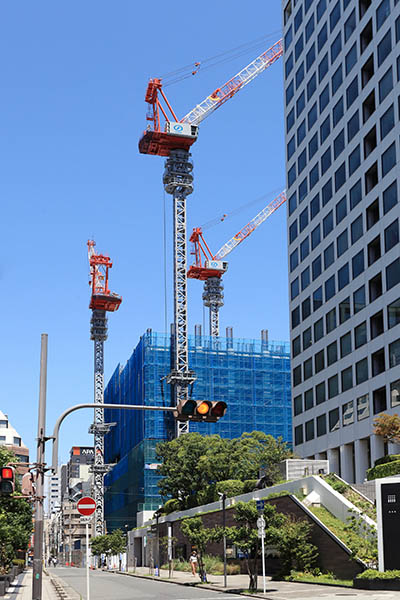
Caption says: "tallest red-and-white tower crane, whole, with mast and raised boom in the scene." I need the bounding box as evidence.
[139,40,283,436]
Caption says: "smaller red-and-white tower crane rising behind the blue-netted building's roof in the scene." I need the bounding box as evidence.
[187,192,286,337]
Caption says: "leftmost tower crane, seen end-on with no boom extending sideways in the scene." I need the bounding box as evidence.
[87,240,122,535]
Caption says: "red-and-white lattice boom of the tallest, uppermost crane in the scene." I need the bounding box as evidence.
[180,40,283,125]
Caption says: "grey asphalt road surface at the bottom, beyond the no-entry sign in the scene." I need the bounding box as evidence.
[48,567,238,600]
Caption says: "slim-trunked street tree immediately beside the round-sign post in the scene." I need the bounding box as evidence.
[226,500,283,592]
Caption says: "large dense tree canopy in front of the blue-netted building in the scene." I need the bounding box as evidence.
[156,431,292,509]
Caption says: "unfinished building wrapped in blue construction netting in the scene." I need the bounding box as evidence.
[104,326,292,531]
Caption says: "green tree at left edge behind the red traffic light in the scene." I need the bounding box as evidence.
[0,446,32,573]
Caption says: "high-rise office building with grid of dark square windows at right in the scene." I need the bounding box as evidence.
[282,0,400,481]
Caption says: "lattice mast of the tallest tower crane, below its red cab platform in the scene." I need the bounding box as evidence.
[163,149,196,437]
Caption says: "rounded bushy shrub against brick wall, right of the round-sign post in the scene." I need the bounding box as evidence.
[276,515,318,575]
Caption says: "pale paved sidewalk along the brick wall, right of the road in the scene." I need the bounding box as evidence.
[119,567,400,600]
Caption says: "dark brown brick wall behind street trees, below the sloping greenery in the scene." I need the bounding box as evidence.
[159,496,364,579]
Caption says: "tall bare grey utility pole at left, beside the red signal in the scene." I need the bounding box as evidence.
[32,333,48,600]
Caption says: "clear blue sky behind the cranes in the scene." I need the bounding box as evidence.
[0,0,289,461]
